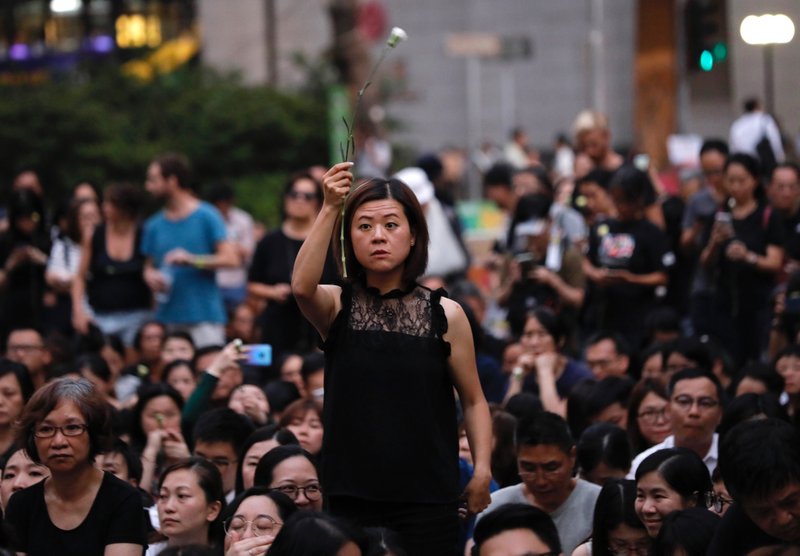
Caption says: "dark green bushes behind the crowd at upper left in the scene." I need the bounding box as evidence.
[0,68,328,224]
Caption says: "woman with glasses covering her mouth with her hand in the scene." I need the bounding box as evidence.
[223,487,297,556]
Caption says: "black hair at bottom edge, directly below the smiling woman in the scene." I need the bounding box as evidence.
[652,505,720,556]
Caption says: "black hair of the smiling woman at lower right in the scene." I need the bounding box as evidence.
[636,448,722,504]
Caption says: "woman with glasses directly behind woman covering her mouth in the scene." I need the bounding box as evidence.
[253,444,322,511]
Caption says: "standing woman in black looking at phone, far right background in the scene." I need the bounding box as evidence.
[700,153,784,366]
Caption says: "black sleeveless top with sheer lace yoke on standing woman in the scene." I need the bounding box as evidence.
[322,284,460,503]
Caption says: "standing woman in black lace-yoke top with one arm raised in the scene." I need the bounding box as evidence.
[292,162,491,555]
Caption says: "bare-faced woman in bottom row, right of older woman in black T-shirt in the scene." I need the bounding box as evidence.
[148,457,225,554]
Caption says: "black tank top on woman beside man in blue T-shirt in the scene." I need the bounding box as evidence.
[86,224,151,313]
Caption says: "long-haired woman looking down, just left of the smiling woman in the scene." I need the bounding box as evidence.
[572,479,652,556]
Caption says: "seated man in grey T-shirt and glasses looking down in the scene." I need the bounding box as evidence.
[478,412,600,554]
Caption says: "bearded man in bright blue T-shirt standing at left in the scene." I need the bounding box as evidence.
[142,154,239,347]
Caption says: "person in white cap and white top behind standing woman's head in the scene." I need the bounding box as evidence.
[392,166,469,281]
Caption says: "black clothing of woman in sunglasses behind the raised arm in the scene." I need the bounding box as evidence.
[247,228,337,359]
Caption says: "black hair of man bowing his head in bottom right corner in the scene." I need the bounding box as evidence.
[719,419,800,500]
